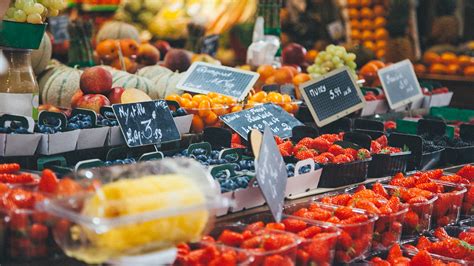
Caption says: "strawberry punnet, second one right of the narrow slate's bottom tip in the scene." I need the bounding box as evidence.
[320,184,408,250]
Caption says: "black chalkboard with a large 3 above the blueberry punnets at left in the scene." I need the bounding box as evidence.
[112,100,181,147]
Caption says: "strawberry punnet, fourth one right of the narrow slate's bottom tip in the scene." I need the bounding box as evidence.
[389,169,466,226]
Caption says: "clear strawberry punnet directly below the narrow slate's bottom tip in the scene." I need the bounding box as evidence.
[239,213,340,266]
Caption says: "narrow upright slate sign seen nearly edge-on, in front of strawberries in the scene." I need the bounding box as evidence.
[255,126,288,222]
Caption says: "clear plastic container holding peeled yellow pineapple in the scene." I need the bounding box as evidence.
[37,158,229,263]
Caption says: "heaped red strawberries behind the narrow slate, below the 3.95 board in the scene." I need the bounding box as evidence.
[277,133,371,164]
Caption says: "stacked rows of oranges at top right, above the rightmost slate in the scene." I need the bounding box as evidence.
[347,0,388,58]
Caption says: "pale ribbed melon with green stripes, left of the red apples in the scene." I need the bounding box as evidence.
[38,65,82,108]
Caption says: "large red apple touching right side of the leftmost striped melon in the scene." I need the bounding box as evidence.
[79,66,112,94]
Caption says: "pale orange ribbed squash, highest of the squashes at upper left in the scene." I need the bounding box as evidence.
[96,21,140,43]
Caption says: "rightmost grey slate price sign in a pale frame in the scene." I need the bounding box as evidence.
[378,59,423,109]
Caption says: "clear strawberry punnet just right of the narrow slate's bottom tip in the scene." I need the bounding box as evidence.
[283,201,378,263]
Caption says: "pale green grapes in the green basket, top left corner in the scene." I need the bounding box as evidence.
[5,0,66,24]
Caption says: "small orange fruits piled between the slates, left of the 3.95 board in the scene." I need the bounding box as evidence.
[245,91,299,114]
